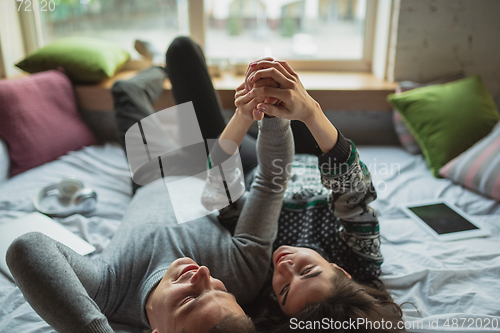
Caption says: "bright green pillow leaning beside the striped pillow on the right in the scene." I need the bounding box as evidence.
[387,76,500,177]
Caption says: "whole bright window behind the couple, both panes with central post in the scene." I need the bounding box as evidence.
[30,0,376,71]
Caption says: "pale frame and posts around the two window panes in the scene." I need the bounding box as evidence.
[13,0,378,72]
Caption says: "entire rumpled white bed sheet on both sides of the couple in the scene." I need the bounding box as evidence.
[0,144,500,333]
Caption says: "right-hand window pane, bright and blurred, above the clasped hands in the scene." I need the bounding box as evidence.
[205,0,366,60]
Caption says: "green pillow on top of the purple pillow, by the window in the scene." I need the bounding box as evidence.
[16,37,130,83]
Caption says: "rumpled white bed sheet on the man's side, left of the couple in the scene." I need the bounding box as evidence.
[0,144,142,333]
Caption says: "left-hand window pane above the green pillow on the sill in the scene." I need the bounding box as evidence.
[40,0,189,56]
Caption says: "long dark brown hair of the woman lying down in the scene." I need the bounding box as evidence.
[255,274,405,333]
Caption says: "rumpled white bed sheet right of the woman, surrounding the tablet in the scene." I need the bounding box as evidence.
[359,147,500,332]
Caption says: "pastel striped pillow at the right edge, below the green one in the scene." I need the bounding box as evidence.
[439,122,500,201]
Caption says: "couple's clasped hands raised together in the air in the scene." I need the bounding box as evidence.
[234,58,321,124]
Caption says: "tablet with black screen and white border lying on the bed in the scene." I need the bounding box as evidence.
[402,201,489,241]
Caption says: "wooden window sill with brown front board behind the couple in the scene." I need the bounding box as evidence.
[75,71,397,111]
